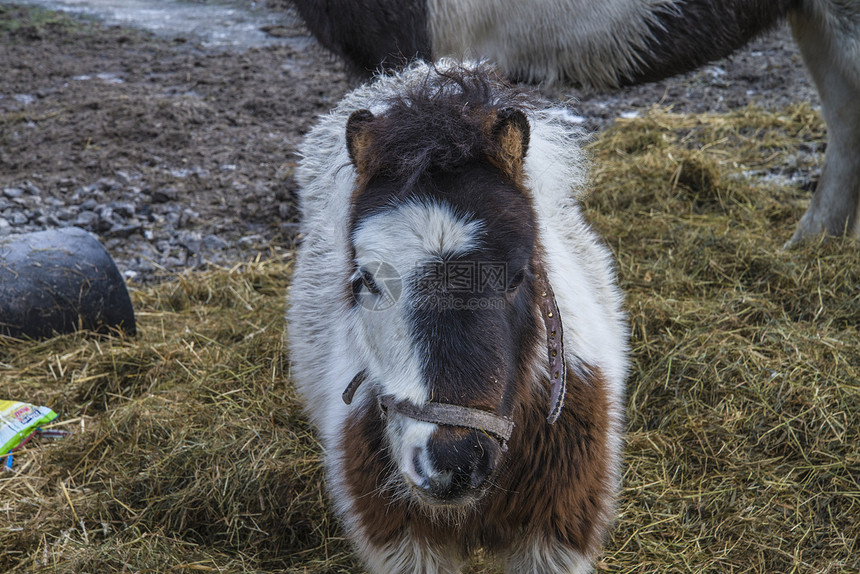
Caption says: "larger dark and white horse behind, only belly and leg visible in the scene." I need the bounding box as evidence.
[294,0,860,242]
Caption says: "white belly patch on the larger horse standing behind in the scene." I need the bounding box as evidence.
[427,0,678,86]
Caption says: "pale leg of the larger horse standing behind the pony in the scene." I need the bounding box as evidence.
[788,4,860,245]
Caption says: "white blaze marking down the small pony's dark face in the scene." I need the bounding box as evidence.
[353,201,483,485]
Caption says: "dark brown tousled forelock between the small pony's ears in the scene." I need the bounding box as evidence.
[356,65,532,186]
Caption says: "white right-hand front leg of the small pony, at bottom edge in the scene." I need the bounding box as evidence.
[505,537,594,574]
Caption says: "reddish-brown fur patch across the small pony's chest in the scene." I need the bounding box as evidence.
[343,364,612,554]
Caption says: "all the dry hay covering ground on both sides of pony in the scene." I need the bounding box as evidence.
[0,107,860,574]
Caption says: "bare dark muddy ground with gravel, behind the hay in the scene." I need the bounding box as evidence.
[0,0,820,281]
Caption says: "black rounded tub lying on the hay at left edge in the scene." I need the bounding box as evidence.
[0,227,137,339]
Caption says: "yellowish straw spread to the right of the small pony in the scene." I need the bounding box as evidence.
[588,106,860,573]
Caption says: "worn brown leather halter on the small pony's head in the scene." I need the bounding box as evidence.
[342,266,567,451]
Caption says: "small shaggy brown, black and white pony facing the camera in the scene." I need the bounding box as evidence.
[288,60,628,574]
